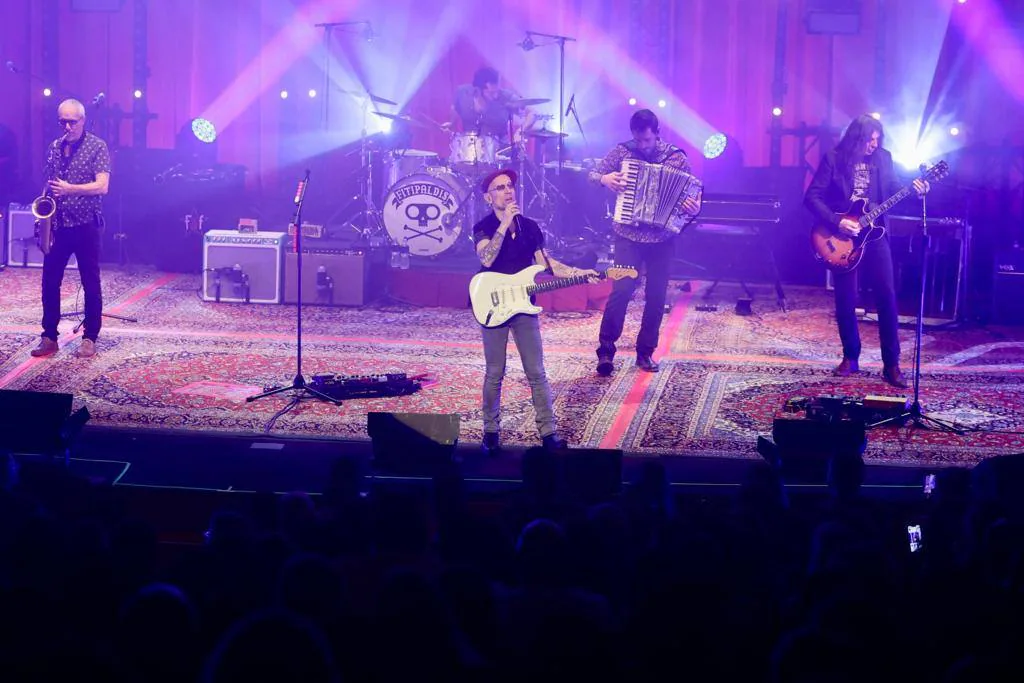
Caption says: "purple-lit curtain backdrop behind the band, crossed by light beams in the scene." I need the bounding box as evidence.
[0,0,1021,196]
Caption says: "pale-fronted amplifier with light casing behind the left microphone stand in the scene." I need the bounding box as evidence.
[203,230,287,303]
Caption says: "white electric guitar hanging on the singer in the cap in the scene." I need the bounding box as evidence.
[469,264,637,328]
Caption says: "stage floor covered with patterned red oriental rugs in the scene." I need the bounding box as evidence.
[0,267,1024,467]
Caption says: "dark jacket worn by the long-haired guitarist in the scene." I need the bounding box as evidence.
[804,147,900,226]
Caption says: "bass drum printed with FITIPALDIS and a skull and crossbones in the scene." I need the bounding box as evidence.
[383,167,471,256]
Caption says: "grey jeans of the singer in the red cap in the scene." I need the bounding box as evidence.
[480,314,555,438]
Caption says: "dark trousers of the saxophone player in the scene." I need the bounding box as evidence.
[42,222,103,341]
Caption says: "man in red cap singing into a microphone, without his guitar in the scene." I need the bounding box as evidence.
[473,170,597,456]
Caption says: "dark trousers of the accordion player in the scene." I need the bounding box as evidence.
[597,237,675,357]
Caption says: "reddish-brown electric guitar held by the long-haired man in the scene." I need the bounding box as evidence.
[811,161,949,272]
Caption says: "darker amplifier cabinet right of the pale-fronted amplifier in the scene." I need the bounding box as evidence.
[285,247,370,306]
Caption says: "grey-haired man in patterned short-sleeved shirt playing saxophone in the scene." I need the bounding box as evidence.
[32,99,111,358]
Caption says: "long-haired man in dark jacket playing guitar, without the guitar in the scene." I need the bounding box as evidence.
[804,114,929,388]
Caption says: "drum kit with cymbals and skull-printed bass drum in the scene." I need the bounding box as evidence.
[333,98,583,258]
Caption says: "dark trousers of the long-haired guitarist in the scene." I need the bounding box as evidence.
[833,237,899,368]
